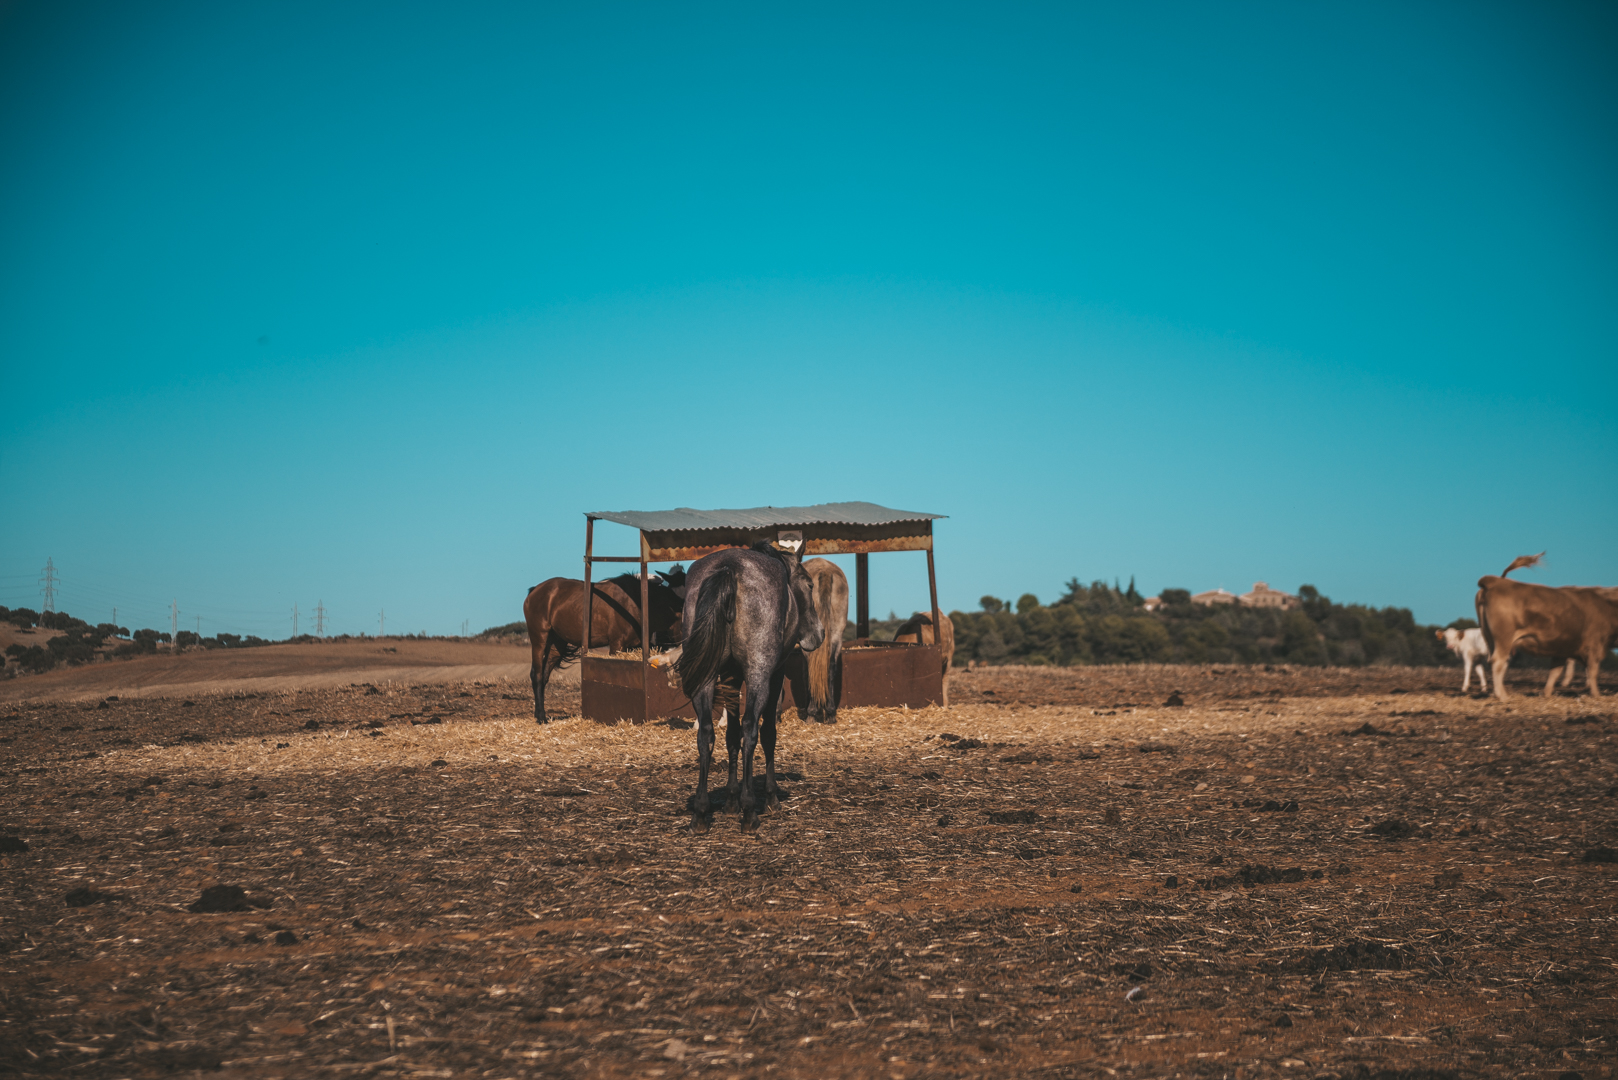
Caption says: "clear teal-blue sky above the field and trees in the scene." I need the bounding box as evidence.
[0,0,1618,636]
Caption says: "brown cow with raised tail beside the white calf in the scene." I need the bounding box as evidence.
[1476,555,1618,699]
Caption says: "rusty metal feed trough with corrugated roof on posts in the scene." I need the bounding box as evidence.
[581,502,943,724]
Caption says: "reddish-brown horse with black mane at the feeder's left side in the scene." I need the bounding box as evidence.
[523,567,686,724]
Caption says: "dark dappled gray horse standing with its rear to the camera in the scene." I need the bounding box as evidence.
[676,541,824,832]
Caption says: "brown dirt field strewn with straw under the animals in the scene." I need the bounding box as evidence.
[0,663,1618,1080]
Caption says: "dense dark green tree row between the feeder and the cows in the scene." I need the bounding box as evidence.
[950,578,1476,667]
